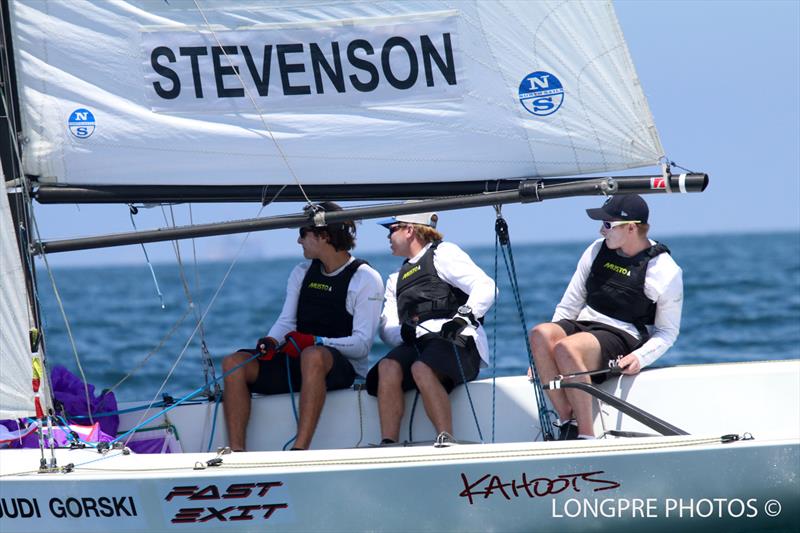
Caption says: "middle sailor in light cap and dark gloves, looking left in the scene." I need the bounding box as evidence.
[367,213,495,445]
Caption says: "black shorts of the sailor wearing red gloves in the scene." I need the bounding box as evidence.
[239,346,356,394]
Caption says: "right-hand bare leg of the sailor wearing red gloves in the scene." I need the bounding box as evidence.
[294,346,333,450]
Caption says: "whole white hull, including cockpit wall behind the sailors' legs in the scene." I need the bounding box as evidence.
[0,361,800,532]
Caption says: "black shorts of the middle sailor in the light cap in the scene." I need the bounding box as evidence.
[367,334,481,396]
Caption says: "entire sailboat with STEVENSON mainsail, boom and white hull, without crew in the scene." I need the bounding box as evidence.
[0,0,800,532]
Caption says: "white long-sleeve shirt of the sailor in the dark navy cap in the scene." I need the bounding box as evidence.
[553,238,683,368]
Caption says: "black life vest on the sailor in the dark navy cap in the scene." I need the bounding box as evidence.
[586,241,670,343]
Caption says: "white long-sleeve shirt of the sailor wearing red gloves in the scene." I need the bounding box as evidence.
[268,257,383,377]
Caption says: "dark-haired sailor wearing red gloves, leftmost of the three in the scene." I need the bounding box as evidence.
[223,202,383,450]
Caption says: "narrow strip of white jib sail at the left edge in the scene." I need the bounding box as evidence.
[0,169,49,419]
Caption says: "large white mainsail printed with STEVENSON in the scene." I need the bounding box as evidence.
[10,0,663,185]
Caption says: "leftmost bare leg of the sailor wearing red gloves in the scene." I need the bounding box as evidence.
[222,352,258,450]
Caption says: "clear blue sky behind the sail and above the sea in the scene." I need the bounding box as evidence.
[26,0,800,266]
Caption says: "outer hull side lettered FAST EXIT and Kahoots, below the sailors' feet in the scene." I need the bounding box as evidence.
[2,437,800,532]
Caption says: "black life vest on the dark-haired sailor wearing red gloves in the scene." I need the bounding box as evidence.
[297,259,366,338]
